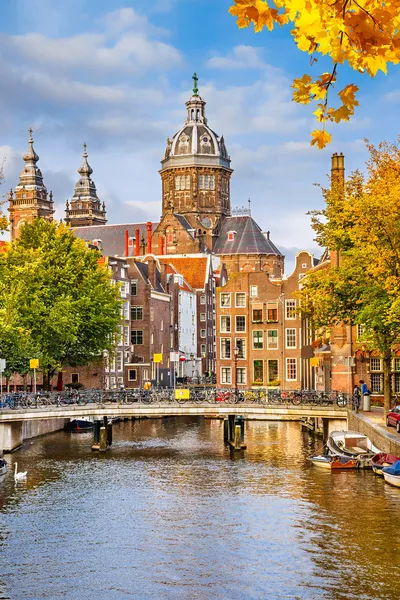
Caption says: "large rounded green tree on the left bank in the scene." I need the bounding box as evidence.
[0,219,121,390]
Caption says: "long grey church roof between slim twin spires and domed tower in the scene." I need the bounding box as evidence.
[74,223,158,256]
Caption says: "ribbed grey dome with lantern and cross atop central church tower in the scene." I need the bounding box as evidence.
[163,74,230,168]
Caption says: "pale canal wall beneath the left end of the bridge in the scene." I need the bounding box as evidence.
[0,419,69,456]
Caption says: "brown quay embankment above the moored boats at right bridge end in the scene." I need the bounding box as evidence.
[348,407,400,456]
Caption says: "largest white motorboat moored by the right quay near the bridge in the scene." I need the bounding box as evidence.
[326,431,380,469]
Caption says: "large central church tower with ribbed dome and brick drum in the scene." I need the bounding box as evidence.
[155,73,233,254]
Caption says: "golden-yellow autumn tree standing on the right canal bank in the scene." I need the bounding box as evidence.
[300,140,400,411]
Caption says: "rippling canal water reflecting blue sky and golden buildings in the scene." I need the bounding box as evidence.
[0,418,400,600]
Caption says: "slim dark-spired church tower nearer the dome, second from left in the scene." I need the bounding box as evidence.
[65,144,107,227]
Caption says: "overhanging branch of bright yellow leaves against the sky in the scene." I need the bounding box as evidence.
[229,0,400,148]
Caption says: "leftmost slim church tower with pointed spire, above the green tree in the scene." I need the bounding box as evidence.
[8,129,54,241]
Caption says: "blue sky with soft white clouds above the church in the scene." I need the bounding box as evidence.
[0,0,400,273]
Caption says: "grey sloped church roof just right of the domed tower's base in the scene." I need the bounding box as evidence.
[214,215,282,256]
